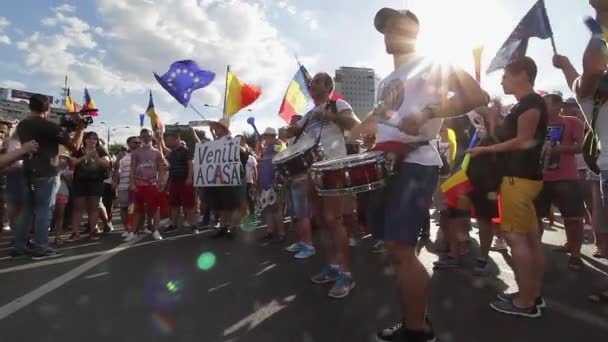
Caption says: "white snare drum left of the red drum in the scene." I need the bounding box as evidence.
[272,135,323,178]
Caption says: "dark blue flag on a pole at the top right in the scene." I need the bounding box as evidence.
[487,0,553,73]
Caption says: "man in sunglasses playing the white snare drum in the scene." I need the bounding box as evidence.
[289,73,359,298]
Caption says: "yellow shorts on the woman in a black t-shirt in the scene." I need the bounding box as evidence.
[500,177,543,233]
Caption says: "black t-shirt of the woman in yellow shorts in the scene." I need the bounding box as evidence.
[498,93,548,180]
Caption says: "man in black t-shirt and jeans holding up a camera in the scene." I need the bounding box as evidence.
[10,94,84,260]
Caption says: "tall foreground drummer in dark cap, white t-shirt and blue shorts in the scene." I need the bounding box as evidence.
[351,8,489,342]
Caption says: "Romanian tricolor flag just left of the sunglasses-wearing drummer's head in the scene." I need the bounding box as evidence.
[279,65,312,123]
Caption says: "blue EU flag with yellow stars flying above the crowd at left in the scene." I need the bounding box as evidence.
[154,60,215,107]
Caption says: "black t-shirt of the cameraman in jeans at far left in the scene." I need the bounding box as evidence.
[17,116,70,178]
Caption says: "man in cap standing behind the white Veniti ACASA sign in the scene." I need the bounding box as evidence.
[203,117,249,239]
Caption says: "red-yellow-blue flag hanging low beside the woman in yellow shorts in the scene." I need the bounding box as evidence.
[440,132,478,208]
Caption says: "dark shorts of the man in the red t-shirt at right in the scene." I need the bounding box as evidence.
[534,180,585,218]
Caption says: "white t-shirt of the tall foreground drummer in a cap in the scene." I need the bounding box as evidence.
[376,56,450,166]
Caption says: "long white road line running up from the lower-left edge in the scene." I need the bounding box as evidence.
[0,237,143,320]
